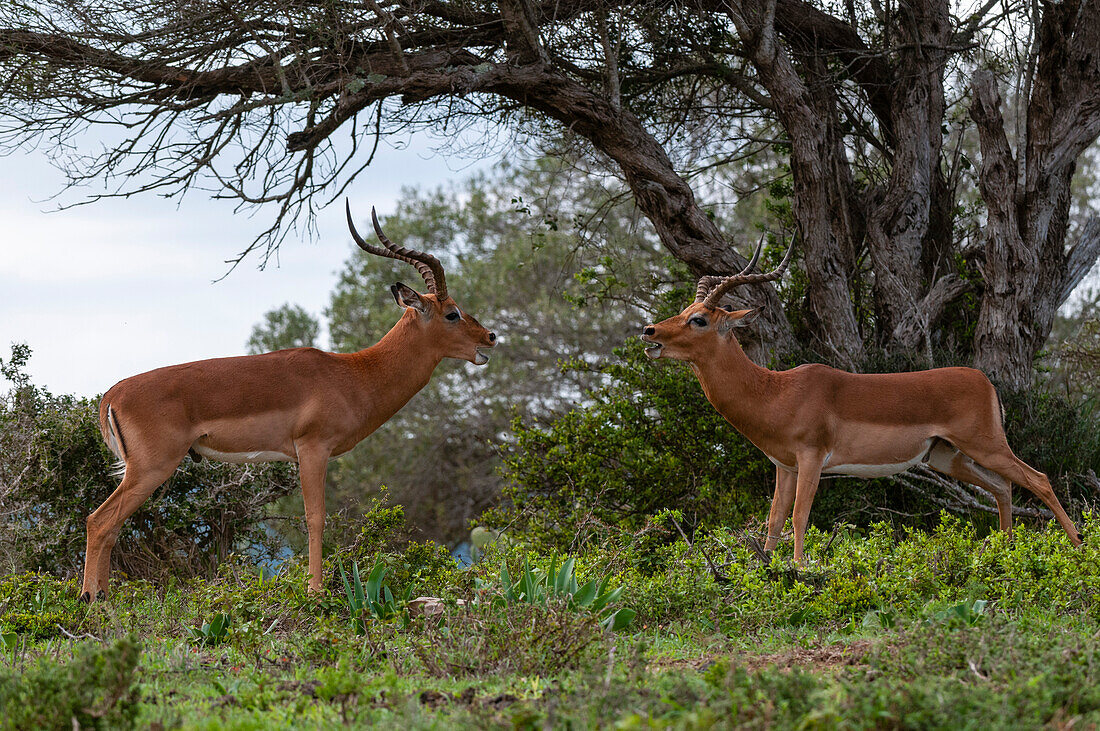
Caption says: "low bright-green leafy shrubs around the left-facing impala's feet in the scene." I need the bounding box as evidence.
[471,512,1100,633]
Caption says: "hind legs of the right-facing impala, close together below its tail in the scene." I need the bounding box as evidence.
[80,455,184,601]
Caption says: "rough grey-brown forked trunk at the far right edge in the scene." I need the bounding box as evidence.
[971,0,1100,388]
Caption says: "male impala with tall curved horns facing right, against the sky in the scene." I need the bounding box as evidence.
[80,206,496,601]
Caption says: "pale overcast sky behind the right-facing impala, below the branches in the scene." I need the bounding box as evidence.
[0,137,487,396]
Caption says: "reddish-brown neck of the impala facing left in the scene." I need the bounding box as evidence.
[691,337,779,433]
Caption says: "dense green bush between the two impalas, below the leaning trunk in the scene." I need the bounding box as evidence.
[495,345,774,549]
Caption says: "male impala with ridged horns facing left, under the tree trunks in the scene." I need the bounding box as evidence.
[641,240,1081,562]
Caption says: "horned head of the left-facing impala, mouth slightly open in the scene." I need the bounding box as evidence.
[641,230,794,361]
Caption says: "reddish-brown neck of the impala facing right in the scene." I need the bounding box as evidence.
[355,311,443,424]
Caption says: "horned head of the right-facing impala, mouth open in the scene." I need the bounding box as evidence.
[347,203,496,365]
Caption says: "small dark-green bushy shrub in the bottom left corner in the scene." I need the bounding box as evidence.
[0,638,141,730]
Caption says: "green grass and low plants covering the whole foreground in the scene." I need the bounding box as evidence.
[0,520,1100,729]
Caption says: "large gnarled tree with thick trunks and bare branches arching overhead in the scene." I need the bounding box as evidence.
[0,0,1100,387]
